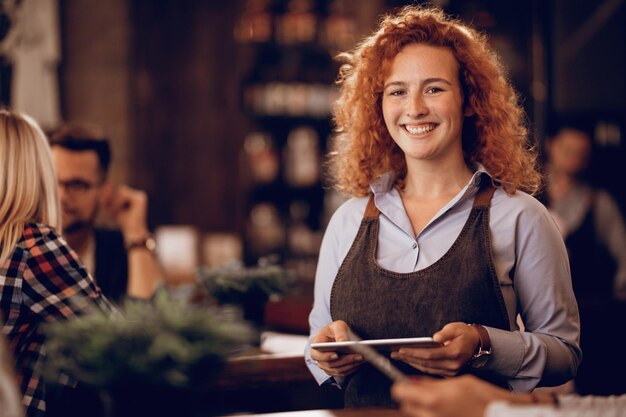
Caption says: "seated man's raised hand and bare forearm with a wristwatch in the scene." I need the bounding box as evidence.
[106,185,164,298]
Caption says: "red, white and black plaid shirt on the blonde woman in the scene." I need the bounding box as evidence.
[0,224,115,417]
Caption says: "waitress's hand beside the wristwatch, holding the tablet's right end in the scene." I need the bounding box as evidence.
[391,322,480,376]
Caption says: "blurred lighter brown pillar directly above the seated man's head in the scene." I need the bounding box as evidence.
[59,0,136,185]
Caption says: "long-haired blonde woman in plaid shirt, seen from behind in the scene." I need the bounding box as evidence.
[0,110,113,417]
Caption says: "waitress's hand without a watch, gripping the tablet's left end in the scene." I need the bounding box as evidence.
[311,320,363,376]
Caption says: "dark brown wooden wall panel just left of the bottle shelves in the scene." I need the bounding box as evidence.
[132,0,243,231]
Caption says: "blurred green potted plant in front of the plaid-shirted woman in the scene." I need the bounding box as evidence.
[45,292,257,417]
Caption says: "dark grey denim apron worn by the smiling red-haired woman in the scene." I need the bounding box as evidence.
[330,178,510,407]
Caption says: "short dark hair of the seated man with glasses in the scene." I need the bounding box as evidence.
[48,124,111,175]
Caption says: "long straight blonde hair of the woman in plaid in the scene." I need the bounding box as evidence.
[0,109,61,265]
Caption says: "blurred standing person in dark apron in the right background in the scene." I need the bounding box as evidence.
[539,117,626,395]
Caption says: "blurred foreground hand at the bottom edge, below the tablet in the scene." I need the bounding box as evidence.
[391,374,516,417]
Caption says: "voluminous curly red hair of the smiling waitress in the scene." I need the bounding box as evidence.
[329,6,541,197]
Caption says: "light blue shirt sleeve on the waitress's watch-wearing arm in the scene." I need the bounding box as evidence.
[488,196,582,391]
